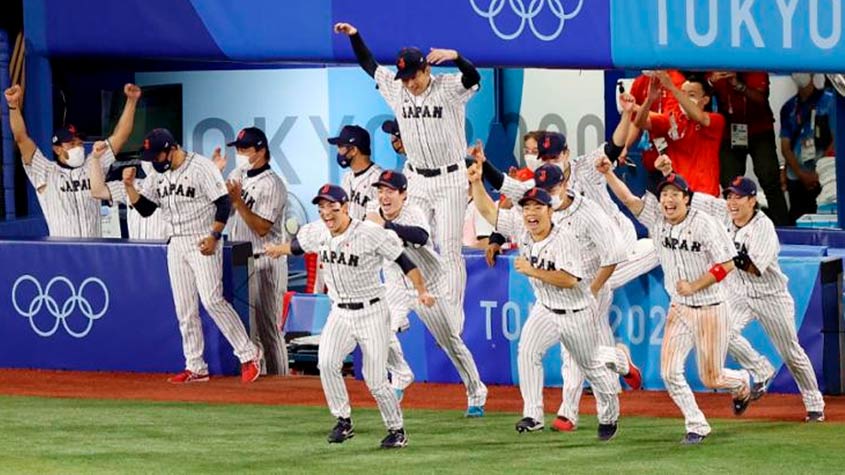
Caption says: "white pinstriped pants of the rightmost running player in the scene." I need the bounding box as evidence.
[728,293,824,412]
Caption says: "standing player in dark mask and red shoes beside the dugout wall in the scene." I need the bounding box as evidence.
[123,129,262,384]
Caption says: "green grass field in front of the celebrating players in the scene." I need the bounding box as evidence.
[0,397,845,475]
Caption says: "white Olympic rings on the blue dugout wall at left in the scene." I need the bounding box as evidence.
[12,275,109,338]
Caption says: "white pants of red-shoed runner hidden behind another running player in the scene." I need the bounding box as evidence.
[557,286,630,425]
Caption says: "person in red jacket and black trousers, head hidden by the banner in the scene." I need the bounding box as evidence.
[709,72,789,226]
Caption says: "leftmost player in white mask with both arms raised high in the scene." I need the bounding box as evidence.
[5,84,141,238]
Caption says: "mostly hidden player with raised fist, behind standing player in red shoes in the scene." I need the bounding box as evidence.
[88,142,168,240]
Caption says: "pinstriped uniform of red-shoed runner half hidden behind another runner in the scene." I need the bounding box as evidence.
[553,193,630,425]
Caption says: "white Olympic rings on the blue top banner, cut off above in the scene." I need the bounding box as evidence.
[469,0,584,41]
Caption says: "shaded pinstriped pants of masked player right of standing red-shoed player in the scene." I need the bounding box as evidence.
[253,256,288,375]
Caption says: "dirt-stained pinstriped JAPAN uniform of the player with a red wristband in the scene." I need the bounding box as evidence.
[638,193,749,435]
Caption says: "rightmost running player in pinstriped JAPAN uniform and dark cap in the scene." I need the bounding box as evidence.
[656,155,824,422]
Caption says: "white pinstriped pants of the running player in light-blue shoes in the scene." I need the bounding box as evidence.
[388,284,487,406]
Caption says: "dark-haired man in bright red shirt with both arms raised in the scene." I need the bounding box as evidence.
[635,71,725,196]
